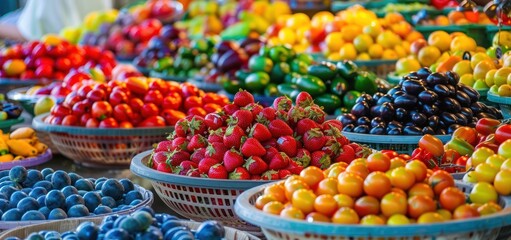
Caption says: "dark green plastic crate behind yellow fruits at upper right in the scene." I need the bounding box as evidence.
[415,24,491,47]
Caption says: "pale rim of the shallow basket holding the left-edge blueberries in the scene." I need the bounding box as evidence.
[0,185,154,231]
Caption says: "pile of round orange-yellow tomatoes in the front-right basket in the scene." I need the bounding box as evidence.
[255,152,502,225]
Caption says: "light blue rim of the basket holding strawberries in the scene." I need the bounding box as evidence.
[130,150,275,190]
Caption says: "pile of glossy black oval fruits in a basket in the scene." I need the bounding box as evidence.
[339,68,502,135]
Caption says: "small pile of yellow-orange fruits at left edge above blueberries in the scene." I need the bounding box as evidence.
[0,127,48,163]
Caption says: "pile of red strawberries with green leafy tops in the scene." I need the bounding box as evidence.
[148,91,368,180]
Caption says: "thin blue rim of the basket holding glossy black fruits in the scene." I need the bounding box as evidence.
[342,131,451,144]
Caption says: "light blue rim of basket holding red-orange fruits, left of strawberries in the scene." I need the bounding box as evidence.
[32,113,174,136]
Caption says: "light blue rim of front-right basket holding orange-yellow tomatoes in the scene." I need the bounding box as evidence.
[234,183,511,237]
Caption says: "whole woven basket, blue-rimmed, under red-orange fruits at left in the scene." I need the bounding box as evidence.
[32,114,174,168]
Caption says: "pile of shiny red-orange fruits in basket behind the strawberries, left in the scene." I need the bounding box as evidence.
[44,77,228,128]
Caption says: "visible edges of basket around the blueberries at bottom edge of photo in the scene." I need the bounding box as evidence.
[0,217,259,240]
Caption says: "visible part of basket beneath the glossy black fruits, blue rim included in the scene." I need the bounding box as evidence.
[342,132,451,154]
